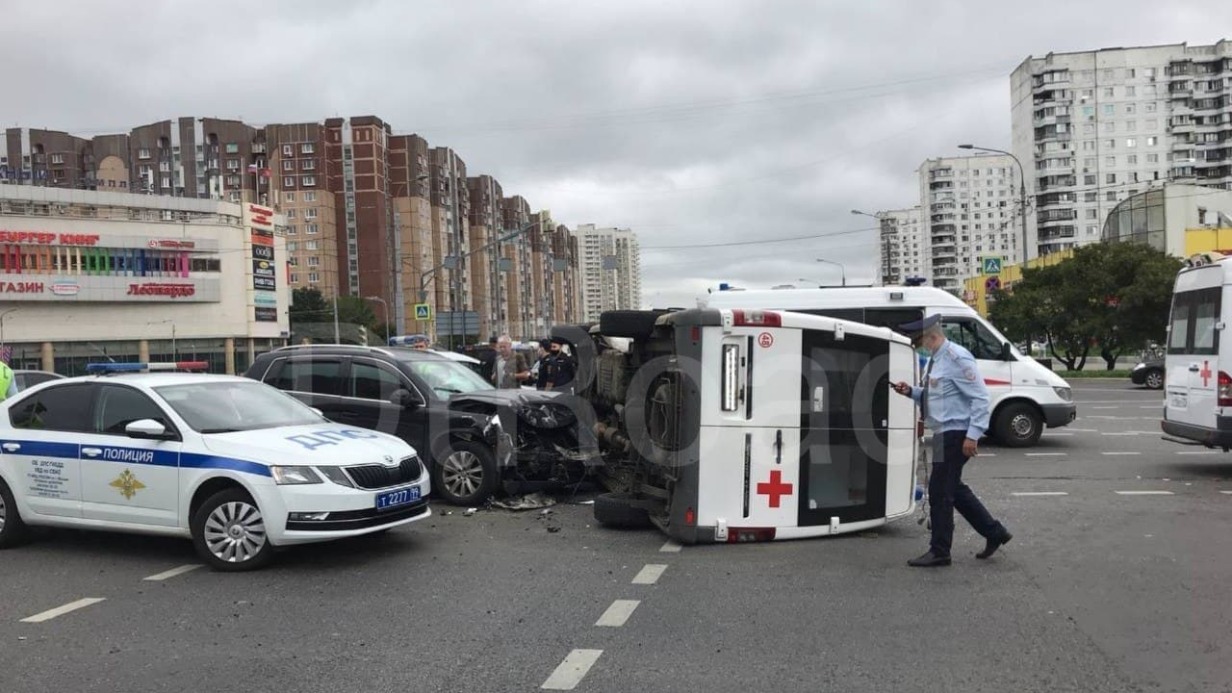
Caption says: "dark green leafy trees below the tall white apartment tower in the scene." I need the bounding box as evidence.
[989,243,1180,370]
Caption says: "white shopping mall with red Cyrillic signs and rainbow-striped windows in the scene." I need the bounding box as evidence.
[0,185,291,375]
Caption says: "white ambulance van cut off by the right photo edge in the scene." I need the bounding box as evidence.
[1162,253,1232,443]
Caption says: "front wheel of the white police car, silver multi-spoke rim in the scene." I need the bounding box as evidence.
[191,488,274,572]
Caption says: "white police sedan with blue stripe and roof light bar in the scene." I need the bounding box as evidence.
[0,361,431,571]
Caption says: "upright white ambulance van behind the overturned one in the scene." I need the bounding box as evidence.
[699,286,1077,448]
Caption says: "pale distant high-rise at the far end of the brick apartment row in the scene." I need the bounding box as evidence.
[575,224,642,322]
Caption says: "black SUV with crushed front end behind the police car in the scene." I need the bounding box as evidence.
[245,344,600,506]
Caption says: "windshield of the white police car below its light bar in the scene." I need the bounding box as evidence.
[154,381,324,433]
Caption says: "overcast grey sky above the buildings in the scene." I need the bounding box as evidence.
[9,0,1232,306]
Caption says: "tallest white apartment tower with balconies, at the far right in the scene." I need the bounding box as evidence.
[1010,41,1232,258]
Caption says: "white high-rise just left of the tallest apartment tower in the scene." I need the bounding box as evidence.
[918,154,1023,292]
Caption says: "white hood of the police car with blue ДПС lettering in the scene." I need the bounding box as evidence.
[201,423,415,466]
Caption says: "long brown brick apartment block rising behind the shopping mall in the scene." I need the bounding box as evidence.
[0,116,582,344]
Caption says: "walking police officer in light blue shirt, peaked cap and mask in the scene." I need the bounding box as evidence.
[893,314,1013,567]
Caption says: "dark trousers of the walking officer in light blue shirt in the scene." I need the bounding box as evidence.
[928,430,1005,556]
